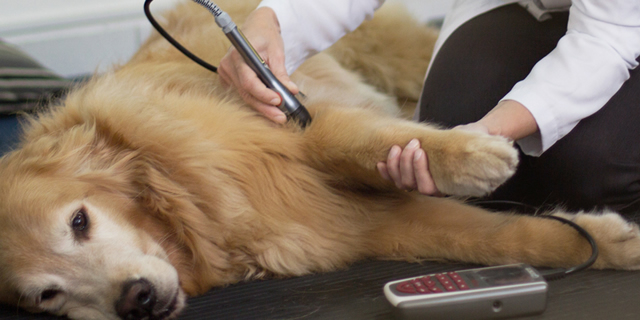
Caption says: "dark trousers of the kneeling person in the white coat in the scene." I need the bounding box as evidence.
[420,5,640,212]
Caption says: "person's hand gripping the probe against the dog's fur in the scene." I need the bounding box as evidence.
[218,7,298,123]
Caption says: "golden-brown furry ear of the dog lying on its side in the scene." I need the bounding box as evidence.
[92,149,231,295]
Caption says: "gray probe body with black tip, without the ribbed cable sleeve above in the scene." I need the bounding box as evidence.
[225,27,311,128]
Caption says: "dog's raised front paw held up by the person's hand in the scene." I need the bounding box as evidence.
[425,129,518,196]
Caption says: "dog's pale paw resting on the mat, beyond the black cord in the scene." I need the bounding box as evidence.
[556,212,640,270]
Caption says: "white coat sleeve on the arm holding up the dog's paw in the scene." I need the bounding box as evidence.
[503,0,640,156]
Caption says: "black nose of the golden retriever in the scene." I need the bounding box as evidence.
[116,278,156,320]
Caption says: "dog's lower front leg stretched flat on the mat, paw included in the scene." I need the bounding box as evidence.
[367,197,640,269]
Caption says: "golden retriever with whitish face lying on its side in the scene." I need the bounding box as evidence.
[0,0,640,319]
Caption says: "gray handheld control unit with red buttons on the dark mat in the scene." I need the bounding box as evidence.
[384,264,547,320]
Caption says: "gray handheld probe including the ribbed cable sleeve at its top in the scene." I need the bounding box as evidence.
[193,0,311,128]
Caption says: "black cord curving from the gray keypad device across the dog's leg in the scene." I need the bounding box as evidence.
[468,200,598,281]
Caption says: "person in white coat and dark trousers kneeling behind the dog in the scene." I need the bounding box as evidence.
[220,0,640,214]
